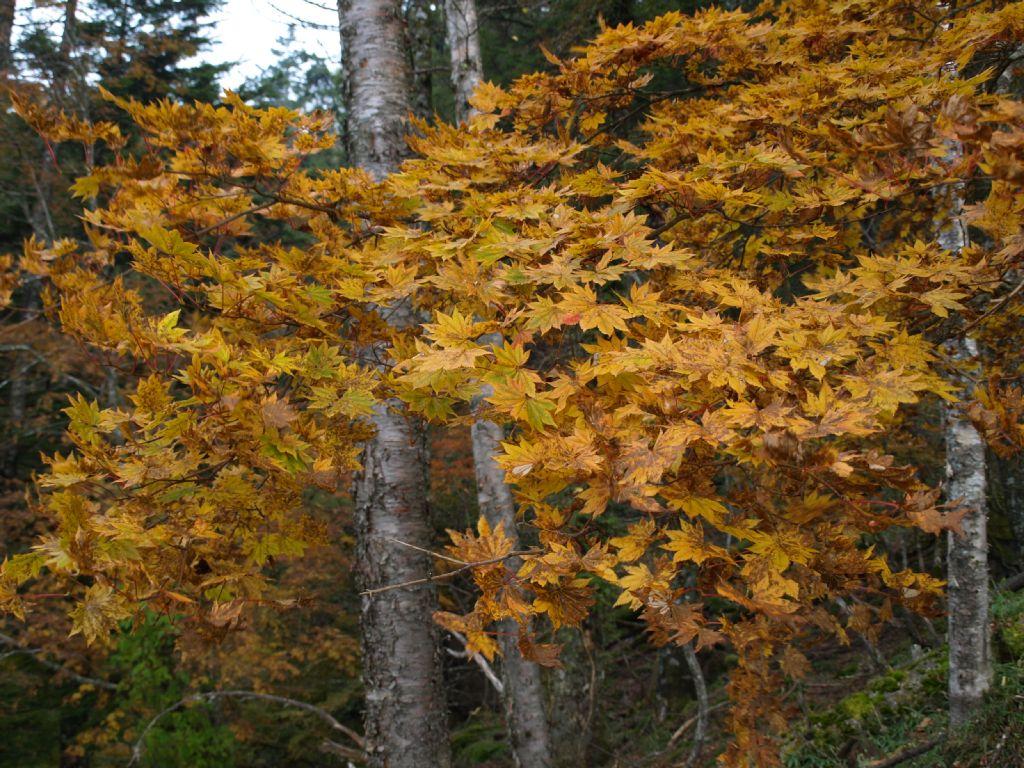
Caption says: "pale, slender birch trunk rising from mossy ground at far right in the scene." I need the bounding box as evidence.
[945,339,991,727]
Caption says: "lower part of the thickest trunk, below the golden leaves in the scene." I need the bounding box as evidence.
[355,402,451,768]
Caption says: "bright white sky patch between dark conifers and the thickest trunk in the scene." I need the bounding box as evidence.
[204,0,341,88]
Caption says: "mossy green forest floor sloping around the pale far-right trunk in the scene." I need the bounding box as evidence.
[679,592,1024,768]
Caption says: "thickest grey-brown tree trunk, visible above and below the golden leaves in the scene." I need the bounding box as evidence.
[338,0,451,768]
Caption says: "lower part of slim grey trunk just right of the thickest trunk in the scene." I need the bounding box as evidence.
[471,405,551,768]
